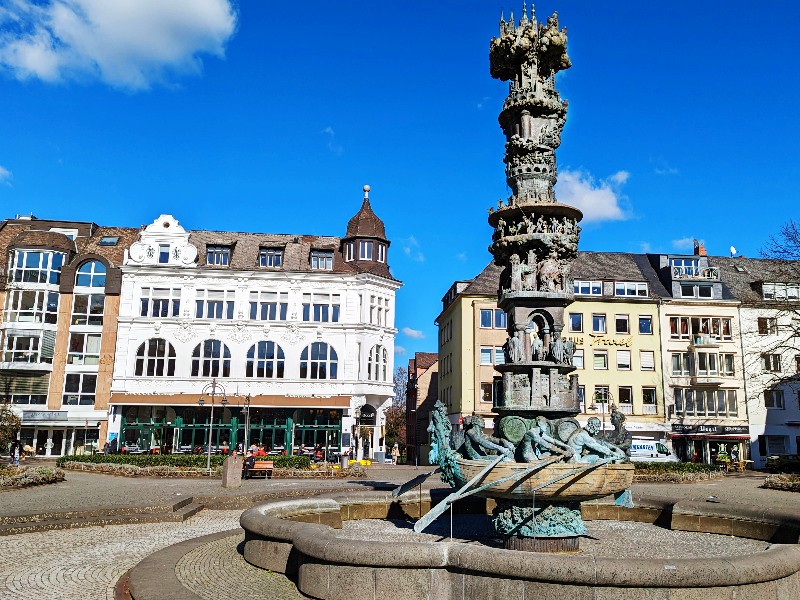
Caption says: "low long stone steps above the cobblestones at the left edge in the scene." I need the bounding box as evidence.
[0,498,203,536]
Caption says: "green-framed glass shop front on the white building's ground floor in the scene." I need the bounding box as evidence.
[118,403,342,453]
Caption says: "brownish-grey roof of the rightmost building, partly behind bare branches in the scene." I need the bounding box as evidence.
[708,256,800,304]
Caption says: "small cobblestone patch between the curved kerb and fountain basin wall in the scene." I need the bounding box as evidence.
[175,535,305,600]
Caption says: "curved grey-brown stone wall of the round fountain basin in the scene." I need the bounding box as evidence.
[241,492,800,600]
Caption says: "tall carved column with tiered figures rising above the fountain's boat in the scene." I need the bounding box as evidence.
[489,5,583,418]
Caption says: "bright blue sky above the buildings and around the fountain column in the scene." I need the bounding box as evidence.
[0,0,800,356]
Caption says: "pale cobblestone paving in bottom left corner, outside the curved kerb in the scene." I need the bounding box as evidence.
[0,510,244,600]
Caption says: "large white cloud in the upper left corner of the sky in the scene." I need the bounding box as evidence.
[0,0,237,90]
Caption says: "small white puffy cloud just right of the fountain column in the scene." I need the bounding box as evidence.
[556,170,630,222]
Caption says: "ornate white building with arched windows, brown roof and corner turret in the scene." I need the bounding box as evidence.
[109,190,401,456]
